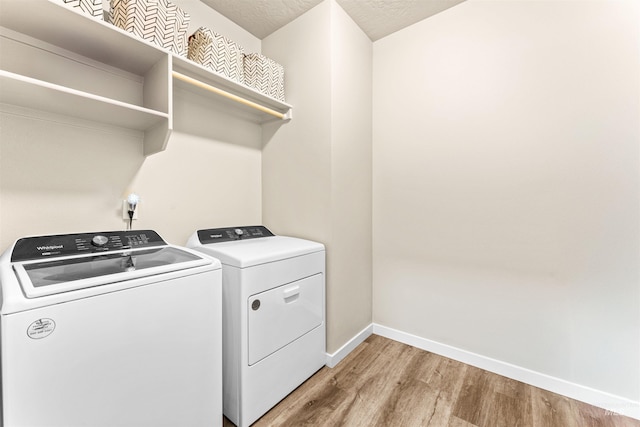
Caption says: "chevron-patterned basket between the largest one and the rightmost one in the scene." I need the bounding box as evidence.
[187,27,244,83]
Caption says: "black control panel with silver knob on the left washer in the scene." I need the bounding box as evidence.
[11,230,166,262]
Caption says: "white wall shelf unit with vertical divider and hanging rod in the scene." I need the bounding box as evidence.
[0,0,292,155]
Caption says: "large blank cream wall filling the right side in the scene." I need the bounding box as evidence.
[373,0,640,402]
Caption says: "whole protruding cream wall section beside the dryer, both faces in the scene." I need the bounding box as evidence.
[262,0,372,353]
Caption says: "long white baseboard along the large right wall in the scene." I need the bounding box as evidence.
[372,323,640,420]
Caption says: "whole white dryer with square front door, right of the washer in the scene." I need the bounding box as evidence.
[187,226,326,427]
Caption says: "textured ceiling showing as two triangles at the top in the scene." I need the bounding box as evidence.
[202,0,464,41]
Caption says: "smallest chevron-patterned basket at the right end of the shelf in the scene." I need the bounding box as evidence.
[244,53,284,102]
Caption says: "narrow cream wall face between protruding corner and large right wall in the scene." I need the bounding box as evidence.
[327,2,373,353]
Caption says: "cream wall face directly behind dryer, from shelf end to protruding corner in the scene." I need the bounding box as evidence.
[262,2,331,247]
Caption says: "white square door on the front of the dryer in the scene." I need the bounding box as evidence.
[247,274,324,365]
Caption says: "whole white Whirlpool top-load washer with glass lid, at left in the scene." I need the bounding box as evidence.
[0,230,222,427]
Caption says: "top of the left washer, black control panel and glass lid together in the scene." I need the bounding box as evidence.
[5,230,217,298]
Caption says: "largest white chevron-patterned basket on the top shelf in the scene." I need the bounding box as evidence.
[109,0,191,56]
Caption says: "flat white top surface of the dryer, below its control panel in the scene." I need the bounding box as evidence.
[192,236,324,268]
